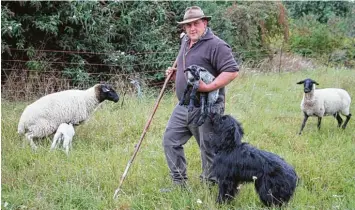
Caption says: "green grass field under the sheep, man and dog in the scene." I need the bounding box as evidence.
[1,68,355,209]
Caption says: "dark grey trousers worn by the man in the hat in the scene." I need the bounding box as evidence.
[163,105,216,183]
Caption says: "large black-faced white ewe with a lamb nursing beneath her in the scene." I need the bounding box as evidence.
[18,84,119,150]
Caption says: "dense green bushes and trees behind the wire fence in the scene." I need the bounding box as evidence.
[1,1,355,91]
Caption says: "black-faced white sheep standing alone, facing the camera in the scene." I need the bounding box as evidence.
[297,79,351,135]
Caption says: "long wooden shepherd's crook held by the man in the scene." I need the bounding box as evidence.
[113,61,176,199]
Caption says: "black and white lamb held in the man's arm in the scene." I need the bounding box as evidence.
[180,65,219,126]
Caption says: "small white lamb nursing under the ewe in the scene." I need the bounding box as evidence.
[51,123,75,155]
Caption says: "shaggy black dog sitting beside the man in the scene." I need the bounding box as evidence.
[212,115,298,206]
